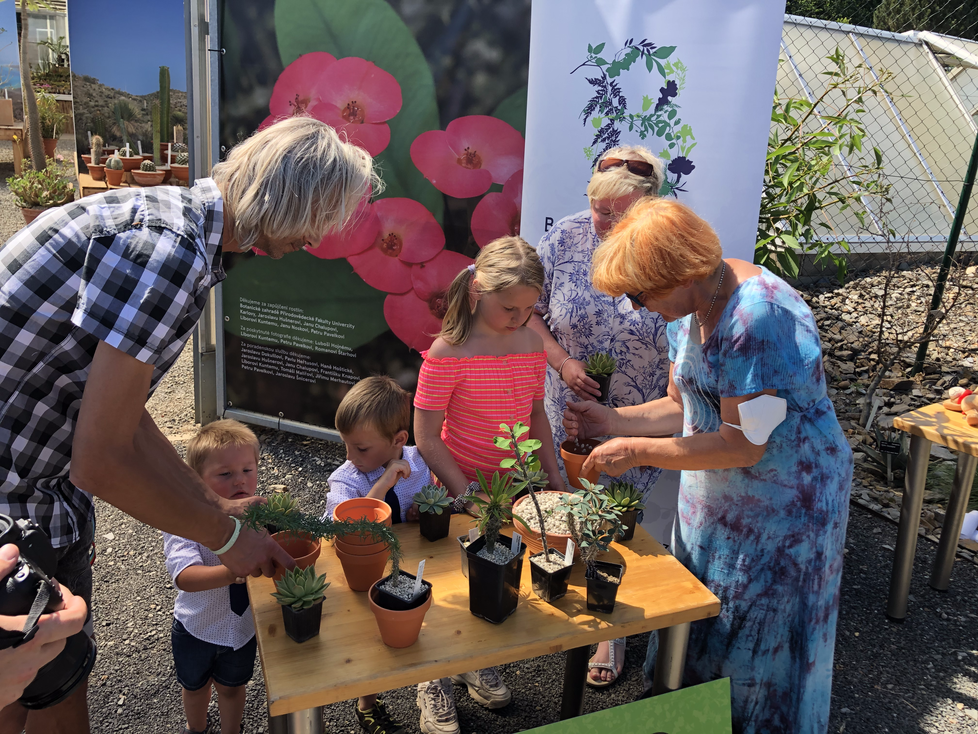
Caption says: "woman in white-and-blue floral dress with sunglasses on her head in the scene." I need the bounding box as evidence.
[529,146,676,686]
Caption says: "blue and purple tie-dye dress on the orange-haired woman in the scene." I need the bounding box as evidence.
[646,269,852,734]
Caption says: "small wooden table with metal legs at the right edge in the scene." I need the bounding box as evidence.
[886,404,978,622]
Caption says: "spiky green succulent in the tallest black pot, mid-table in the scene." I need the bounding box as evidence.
[465,469,526,624]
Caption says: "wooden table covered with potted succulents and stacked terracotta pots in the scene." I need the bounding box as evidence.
[248,515,720,734]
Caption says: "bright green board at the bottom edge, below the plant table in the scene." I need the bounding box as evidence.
[528,678,731,734]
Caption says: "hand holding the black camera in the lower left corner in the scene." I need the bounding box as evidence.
[0,544,88,709]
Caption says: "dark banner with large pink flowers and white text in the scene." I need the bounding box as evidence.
[220,0,530,428]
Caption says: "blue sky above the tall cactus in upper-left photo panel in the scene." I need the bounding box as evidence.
[68,0,187,95]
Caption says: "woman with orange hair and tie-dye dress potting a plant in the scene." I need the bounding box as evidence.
[564,199,852,734]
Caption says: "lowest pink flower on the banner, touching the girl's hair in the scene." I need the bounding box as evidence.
[384,250,474,352]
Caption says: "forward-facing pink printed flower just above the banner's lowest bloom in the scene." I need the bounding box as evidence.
[347,199,445,293]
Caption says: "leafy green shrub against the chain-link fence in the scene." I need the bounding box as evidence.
[754,48,892,282]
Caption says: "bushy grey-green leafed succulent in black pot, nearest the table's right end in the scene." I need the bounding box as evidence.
[558,479,625,613]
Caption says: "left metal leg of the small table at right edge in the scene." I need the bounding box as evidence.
[886,436,931,622]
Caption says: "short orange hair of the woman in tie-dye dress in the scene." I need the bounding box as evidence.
[591,199,723,297]
